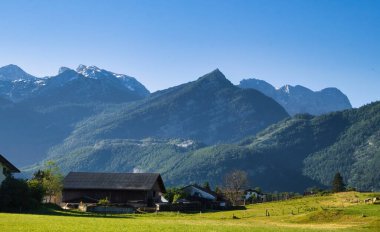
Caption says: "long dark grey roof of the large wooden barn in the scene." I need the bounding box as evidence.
[63,172,165,192]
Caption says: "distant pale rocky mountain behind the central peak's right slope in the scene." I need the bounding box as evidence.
[239,79,352,115]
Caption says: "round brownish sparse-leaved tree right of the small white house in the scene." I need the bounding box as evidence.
[223,170,248,206]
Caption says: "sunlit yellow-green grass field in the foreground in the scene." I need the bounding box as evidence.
[0,192,380,231]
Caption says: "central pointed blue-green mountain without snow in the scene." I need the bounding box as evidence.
[40,70,288,154]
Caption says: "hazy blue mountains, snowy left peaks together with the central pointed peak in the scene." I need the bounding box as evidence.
[0,65,289,165]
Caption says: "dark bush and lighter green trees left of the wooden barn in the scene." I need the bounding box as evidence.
[0,162,63,212]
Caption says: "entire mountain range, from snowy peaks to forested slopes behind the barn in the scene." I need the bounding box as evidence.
[0,65,379,191]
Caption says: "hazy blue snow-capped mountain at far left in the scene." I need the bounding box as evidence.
[0,65,149,165]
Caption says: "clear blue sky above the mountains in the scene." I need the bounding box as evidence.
[0,0,380,107]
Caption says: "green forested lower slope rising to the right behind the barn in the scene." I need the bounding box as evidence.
[26,102,380,192]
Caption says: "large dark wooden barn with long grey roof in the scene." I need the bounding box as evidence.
[62,172,165,207]
